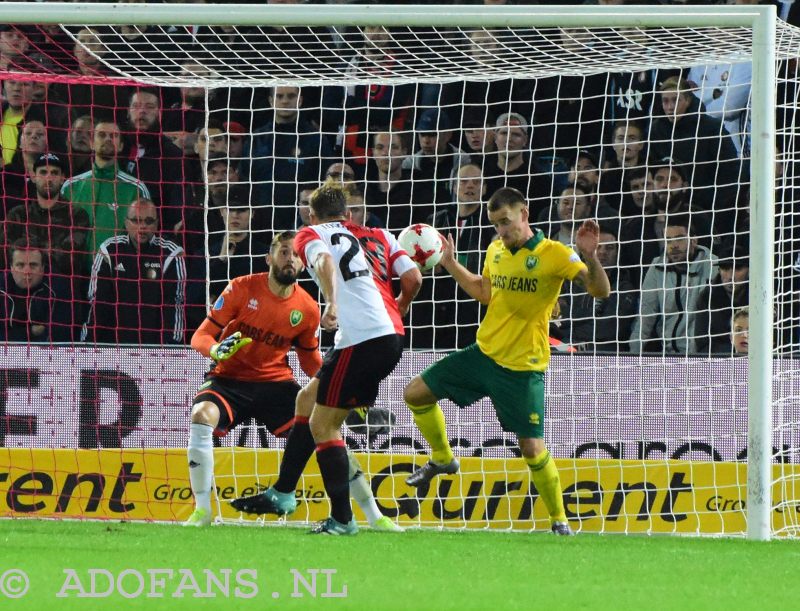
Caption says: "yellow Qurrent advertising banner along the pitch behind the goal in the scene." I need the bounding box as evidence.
[0,448,800,534]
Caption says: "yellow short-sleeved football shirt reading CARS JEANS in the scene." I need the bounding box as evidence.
[477,231,586,371]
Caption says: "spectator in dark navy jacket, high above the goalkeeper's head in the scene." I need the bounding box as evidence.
[244,86,332,231]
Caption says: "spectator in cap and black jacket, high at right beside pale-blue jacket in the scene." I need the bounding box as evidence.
[650,77,743,210]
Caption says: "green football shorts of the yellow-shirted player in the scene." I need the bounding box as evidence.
[420,344,544,438]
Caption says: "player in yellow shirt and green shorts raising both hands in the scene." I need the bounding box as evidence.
[404,188,611,535]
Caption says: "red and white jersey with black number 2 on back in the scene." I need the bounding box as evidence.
[294,221,414,348]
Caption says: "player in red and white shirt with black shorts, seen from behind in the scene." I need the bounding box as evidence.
[241,183,422,535]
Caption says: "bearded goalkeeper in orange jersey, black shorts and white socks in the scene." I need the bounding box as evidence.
[184,231,402,531]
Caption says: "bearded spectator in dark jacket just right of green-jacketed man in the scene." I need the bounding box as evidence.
[123,89,188,231]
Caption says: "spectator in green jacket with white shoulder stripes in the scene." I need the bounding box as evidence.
[61,120,150,261]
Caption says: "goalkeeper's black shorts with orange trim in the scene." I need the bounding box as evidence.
[193,376,300,437]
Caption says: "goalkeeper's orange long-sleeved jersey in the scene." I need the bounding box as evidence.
[198,273,322,382]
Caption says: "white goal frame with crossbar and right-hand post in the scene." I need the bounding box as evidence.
[0,2,788,540]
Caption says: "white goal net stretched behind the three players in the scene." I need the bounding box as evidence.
[0,3,800,537]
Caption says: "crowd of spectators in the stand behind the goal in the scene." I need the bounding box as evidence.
[0,2,796,355]
